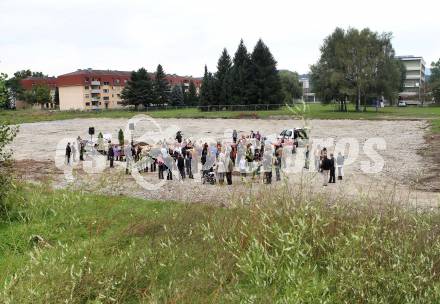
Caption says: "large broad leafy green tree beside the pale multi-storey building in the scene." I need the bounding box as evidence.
[311,28,402,111]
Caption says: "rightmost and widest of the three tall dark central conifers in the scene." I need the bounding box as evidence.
[249,39,282,104]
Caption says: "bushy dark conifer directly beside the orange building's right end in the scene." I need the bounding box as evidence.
[121,68,155,109]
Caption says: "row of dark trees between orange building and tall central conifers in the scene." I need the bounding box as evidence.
[121,64,198,109]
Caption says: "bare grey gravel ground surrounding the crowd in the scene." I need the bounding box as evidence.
[12,119,440,206]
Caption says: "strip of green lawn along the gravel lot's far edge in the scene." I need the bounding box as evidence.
[0,104,440,130]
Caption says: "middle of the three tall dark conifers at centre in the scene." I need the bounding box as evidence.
[230,39,252,104]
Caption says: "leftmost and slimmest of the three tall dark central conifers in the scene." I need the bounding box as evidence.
[215,49,232,104]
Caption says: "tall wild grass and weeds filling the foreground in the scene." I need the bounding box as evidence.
[0,185,440,303]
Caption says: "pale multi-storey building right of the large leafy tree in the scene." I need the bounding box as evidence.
[397,56,426,101]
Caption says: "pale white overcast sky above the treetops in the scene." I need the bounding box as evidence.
[0,0,440,76]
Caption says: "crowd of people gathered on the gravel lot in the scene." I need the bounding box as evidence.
[66,130,345,186]
